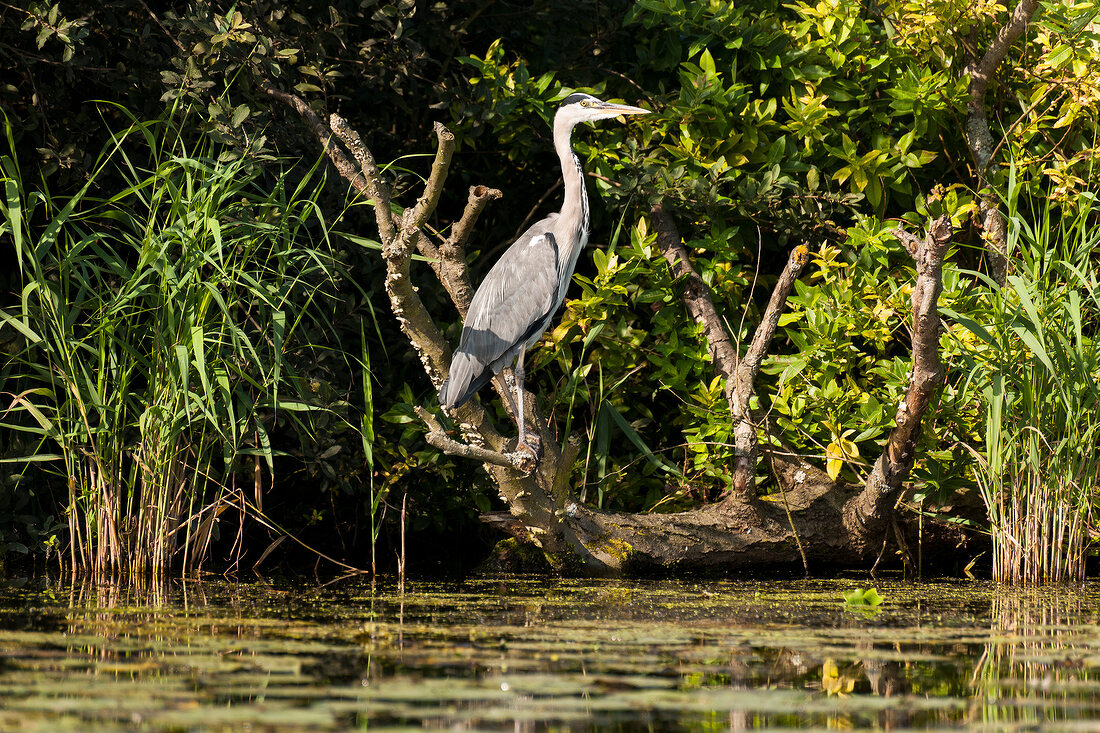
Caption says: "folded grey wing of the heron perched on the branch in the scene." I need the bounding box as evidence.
[440,218,562,407]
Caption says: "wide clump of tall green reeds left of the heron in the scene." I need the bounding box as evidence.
[0,112,347,575]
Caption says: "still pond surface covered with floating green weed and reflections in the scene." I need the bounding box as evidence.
[0,577,1100,732]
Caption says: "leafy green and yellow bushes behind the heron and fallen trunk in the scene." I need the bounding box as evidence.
[0,0,1100,561]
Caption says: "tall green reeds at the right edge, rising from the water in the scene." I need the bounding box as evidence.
[969,173,1100,583]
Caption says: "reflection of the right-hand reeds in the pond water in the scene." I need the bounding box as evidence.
[968,588,1100,723]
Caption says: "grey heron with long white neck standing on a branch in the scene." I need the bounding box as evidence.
[439,94,649,453]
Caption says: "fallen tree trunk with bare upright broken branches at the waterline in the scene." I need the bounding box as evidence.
[265,86,976,575]
